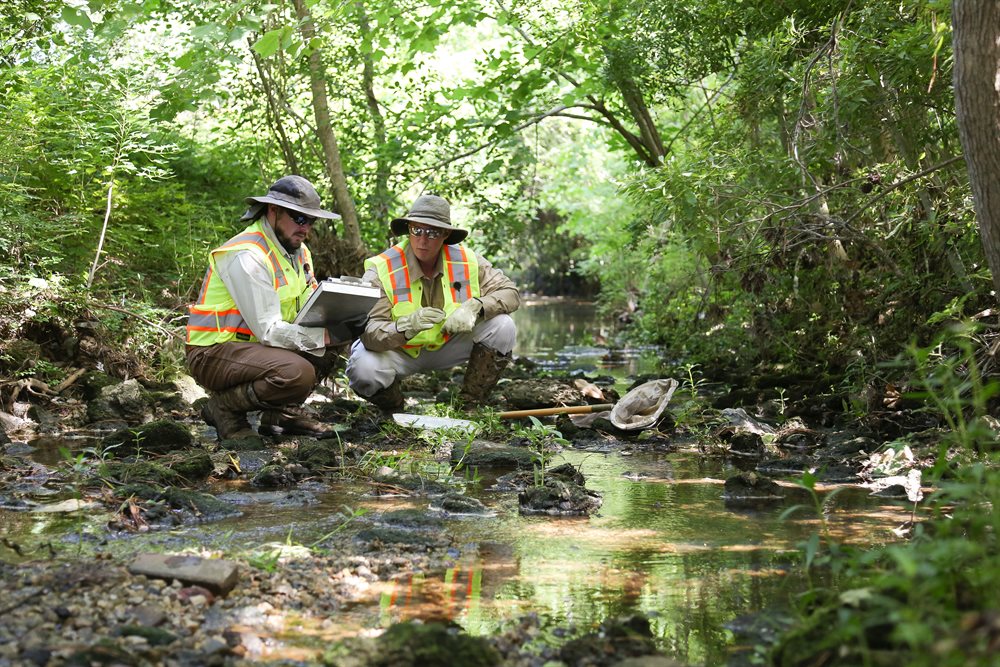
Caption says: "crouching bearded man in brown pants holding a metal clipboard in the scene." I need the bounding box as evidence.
[187,176,360,440]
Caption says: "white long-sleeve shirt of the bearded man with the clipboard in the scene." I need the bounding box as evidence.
[215,224,326,356]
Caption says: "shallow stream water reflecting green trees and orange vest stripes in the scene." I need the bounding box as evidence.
[0,301,910,665]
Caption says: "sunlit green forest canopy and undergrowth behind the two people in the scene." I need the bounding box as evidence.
[0,0,994,383]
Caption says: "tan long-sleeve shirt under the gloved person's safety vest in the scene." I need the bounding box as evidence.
[361,246,521,352]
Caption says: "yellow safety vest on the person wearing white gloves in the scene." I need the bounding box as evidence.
[365,239,480,357]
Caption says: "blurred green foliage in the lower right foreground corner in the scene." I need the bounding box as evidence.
[768,327,1000,667]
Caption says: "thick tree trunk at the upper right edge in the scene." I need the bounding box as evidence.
[951,0,1000,294]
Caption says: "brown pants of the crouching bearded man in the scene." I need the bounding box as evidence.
[187,342,340,406]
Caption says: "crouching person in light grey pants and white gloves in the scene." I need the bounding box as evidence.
[347,195,520,412]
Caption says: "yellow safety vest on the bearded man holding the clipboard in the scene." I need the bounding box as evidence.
[187,220,317,346]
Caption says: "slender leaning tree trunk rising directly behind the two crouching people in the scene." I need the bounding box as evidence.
[293,0,367,275]
